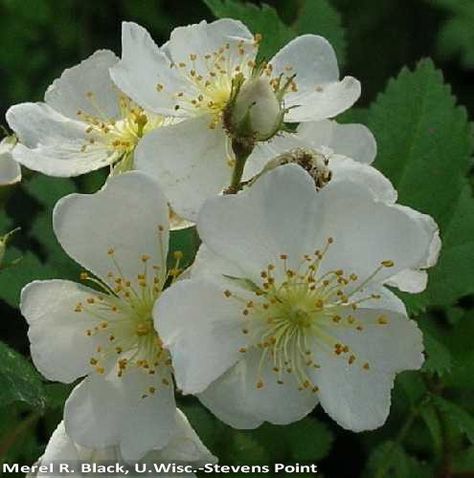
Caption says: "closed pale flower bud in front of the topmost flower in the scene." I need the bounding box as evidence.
[230,77,284,141]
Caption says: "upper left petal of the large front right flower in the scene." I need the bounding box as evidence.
[198,165,322,281]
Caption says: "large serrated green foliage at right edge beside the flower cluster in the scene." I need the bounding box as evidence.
[368,60,474,312]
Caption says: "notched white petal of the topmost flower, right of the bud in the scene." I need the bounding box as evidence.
[270,35,360,122]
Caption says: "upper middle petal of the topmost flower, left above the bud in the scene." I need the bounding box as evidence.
[166,18,256,76]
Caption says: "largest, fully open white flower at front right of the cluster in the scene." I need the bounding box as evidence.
[154,160,437,431]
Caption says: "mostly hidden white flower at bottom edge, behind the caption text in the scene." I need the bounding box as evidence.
[28,410,216,478]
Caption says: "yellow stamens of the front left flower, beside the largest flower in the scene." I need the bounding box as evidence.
[74,227,182,396]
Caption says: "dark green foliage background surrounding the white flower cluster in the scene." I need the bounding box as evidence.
[0,0,474,478]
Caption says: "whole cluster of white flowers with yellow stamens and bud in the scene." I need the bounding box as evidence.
[0,19,440,470]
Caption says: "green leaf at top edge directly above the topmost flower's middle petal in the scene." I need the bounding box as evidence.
[204,0,294,60]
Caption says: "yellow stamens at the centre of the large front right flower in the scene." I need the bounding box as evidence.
[224,238,394,392]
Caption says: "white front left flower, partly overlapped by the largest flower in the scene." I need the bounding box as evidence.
[20,171,187,460]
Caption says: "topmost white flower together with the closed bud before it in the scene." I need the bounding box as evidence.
[111,19,360,220]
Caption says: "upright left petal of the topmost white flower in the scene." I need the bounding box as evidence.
[110,22,189,116]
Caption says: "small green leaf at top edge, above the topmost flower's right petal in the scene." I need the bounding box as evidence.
[292,0,347,65]
